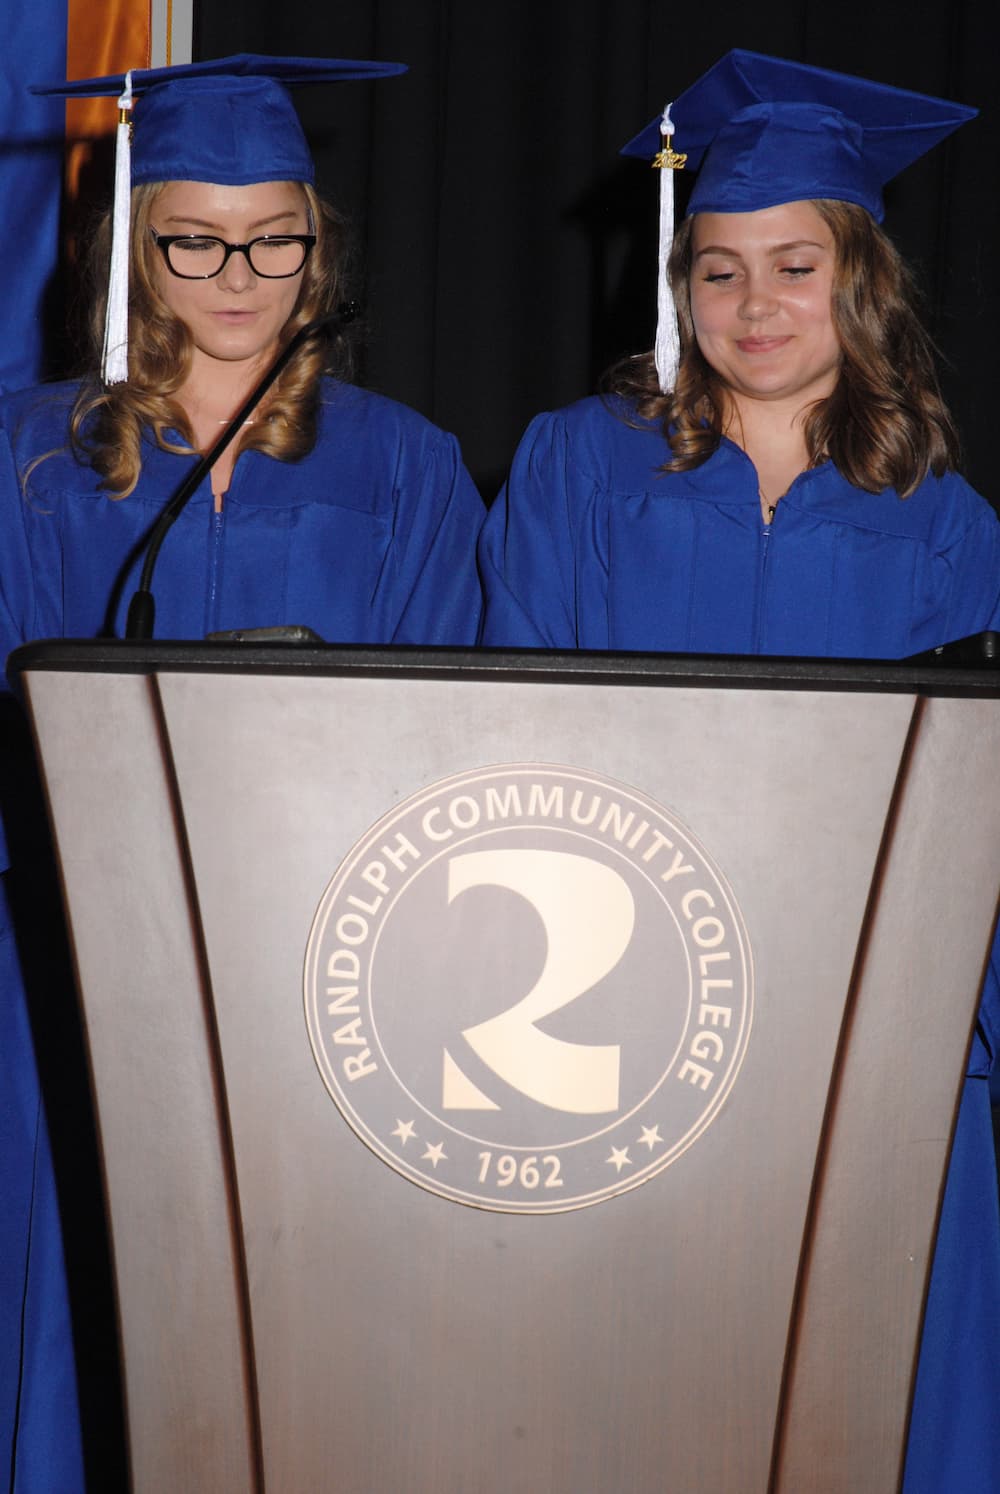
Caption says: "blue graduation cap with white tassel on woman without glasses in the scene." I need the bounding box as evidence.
[622,49,978,388]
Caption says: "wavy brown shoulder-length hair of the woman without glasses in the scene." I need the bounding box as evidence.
[605,199,960,498]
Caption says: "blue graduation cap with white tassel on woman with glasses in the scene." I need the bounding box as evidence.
[30,52,407,384]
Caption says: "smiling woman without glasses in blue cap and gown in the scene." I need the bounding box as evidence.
[480,62,1000,657]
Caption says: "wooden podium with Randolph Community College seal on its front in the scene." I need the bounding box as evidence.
[13,644,1000,1494]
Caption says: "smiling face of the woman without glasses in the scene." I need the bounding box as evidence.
[689,202,842,408]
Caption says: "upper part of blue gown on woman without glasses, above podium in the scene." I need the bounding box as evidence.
[480,399,1000,659]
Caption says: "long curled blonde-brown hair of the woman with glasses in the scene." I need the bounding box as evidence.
[70,182,351,498]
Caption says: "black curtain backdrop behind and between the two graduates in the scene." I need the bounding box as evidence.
[196,0,1000,500]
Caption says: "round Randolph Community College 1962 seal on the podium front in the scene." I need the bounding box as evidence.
[305,763,753,1213]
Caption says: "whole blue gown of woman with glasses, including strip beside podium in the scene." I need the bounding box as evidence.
[0,379,483,1494]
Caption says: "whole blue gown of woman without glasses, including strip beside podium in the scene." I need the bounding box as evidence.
[480,399,1000,1494]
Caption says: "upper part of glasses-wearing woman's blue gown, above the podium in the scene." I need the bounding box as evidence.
[0,379,483,648]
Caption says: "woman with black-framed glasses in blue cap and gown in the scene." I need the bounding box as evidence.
[0,58,481,647]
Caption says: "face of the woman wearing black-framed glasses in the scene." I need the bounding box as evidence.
[149,182,311,373]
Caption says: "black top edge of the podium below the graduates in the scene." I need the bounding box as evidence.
[7,635,1000,698]
